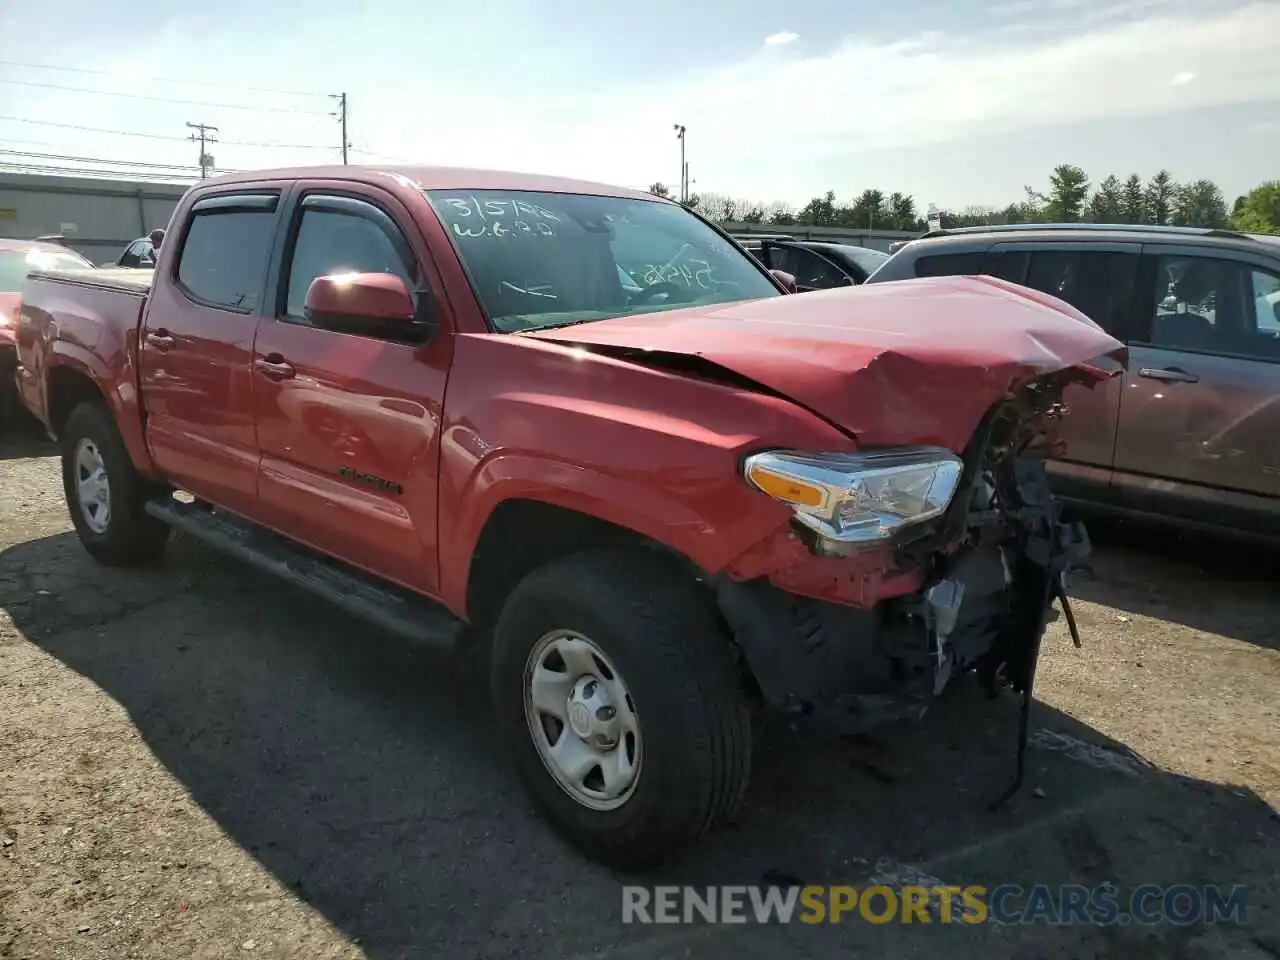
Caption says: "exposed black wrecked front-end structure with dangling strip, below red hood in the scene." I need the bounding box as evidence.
[709,384,1089,810]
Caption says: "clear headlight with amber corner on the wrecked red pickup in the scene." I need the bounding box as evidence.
[742,447,964,548]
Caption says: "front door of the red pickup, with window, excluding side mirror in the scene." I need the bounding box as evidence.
[253,184,452,593]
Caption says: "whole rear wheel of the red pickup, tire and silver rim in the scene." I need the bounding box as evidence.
[61,402,169,566]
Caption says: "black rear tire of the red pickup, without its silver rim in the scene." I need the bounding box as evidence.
[61,402,169,567]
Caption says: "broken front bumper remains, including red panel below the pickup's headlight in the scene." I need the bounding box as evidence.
[714,458,1089,733]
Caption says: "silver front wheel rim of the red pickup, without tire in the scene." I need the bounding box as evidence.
[524,630,641,810]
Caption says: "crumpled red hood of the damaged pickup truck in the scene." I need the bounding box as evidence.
[525,276,1128,452]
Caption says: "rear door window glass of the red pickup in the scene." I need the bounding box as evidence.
[178,207,275,312]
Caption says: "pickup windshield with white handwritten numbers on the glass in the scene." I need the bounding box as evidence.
[428,189,781,333]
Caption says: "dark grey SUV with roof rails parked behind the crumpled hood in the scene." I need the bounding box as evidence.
[869,224,1280,539]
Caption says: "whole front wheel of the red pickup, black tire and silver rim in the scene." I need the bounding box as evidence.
[490,552,751,869]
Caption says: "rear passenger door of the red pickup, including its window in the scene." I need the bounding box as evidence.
[138,188,280,517]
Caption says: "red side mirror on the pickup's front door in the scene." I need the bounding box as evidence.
[303,274,425,340]
